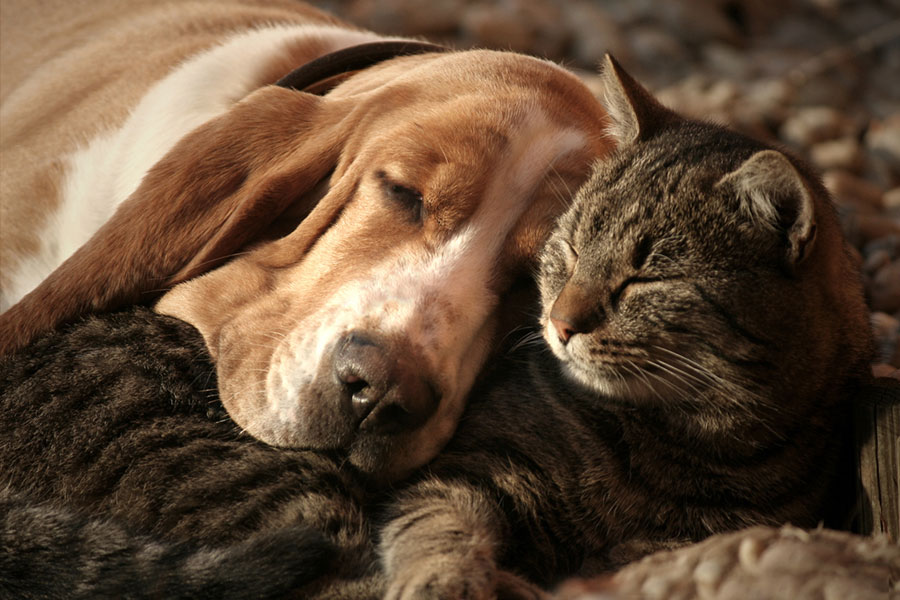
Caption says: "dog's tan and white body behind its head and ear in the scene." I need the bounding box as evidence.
[0,0,358,302]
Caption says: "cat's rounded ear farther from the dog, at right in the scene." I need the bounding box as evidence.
[717,150,816,265]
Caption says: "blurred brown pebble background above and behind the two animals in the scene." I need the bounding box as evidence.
[313,0,900,370]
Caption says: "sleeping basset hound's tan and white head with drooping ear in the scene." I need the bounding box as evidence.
[1,51,608,480]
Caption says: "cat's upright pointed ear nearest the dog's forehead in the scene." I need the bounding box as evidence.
[601,54,674,145]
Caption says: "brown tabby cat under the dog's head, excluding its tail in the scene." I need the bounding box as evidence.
[0,61,871,599]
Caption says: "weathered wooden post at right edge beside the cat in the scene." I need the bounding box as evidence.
[854,378,900,543]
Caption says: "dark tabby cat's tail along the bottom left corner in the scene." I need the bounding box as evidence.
[0,490,335,600]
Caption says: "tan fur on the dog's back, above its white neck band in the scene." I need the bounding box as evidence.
[0,0,337,287]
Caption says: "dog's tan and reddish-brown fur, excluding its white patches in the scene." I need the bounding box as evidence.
[0,0,610,476]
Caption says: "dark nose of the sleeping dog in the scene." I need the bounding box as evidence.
[334,331,438,434]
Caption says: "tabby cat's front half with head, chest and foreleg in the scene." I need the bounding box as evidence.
[372,58,872,599]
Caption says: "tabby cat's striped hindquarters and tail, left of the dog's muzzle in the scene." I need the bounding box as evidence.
[0,307,374,599]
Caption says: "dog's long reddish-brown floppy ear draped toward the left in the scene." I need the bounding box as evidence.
[0,86,345,355]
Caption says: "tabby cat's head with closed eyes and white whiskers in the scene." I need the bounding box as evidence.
[540,57,871,406]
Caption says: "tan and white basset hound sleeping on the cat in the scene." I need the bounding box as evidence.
[0,0,611,481]
